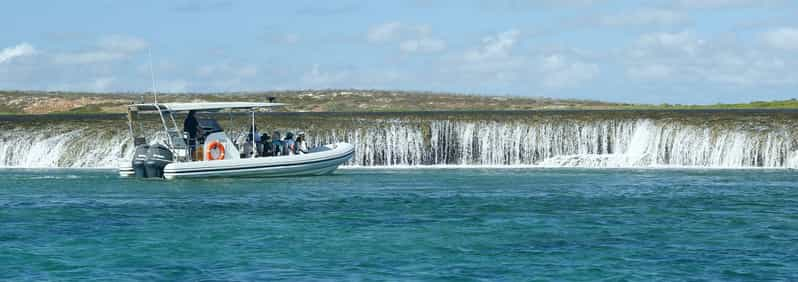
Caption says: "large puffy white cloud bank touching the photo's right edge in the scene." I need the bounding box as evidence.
[619,32,798,87]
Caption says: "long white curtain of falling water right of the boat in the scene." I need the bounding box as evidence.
[317,119,798,168]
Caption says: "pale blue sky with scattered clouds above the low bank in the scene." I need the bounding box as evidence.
[0,0,798,103]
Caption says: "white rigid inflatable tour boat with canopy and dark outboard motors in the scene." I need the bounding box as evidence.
[119,102,354,179]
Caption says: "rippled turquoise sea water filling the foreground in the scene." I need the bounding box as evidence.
[0,169,798,281]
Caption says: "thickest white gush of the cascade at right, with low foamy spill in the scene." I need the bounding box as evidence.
[542,120,796,168]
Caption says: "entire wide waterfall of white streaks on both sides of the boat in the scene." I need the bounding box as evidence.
[0,114,798,168]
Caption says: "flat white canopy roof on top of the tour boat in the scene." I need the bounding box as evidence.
[128,102,285,112]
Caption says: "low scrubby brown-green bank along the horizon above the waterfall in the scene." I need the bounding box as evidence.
[0,89,798,115]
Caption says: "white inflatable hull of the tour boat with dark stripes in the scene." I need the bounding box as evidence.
[119,143,354,179]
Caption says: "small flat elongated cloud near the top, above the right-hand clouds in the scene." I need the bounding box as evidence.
[599,9,687,26]
